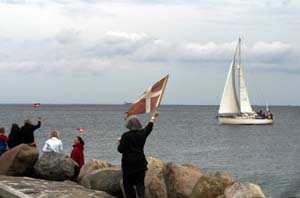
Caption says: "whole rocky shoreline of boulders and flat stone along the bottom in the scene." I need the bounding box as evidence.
[0,144,265,198]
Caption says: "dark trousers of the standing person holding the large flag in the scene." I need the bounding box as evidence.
[123,171,146,198]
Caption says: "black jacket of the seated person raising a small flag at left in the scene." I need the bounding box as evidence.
[18,121,41,144]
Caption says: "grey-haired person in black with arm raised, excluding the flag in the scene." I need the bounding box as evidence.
[118,112,158,198]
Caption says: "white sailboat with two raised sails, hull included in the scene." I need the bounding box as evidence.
[218,39,273,124]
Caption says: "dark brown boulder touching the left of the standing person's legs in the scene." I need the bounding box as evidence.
[81,167,122,197]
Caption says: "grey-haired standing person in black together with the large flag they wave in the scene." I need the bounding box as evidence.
[118,75,169,198]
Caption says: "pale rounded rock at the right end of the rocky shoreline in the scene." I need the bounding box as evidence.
[224,182,265,198]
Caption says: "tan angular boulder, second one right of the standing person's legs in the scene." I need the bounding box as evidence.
[164,162,203,198]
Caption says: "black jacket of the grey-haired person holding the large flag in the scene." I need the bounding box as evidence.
[118,122,153,175]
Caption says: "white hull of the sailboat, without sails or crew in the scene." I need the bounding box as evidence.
[219,117,273,125]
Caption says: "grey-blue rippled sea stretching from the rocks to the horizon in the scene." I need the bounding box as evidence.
[0,104,300,198]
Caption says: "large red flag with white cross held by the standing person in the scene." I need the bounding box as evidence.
[126,75,169,118]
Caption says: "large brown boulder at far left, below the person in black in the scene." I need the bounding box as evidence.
[0,144,39,176]
